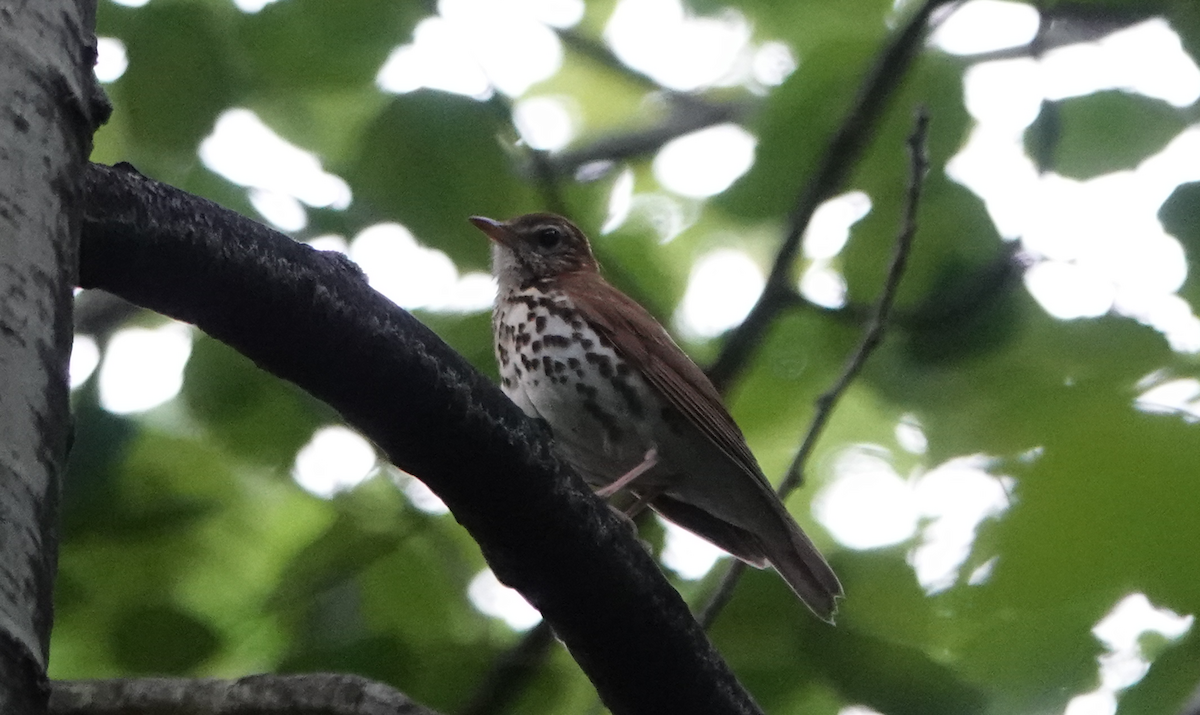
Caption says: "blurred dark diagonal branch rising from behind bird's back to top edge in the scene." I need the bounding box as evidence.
[708,0,958,391]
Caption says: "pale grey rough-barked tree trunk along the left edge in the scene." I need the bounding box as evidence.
[0,0,106,715]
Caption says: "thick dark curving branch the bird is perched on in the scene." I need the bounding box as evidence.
[80,164,758,714]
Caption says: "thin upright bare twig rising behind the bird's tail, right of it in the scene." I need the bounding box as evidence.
[697,107,929,629]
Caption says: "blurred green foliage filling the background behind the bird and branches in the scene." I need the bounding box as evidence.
[63,0,1200,715]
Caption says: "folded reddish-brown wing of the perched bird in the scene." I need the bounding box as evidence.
[559,272,772,491]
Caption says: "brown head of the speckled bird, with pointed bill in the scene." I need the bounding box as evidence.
[470,214,598,288]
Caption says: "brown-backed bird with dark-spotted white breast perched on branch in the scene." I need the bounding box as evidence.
[469,214,842,623]
